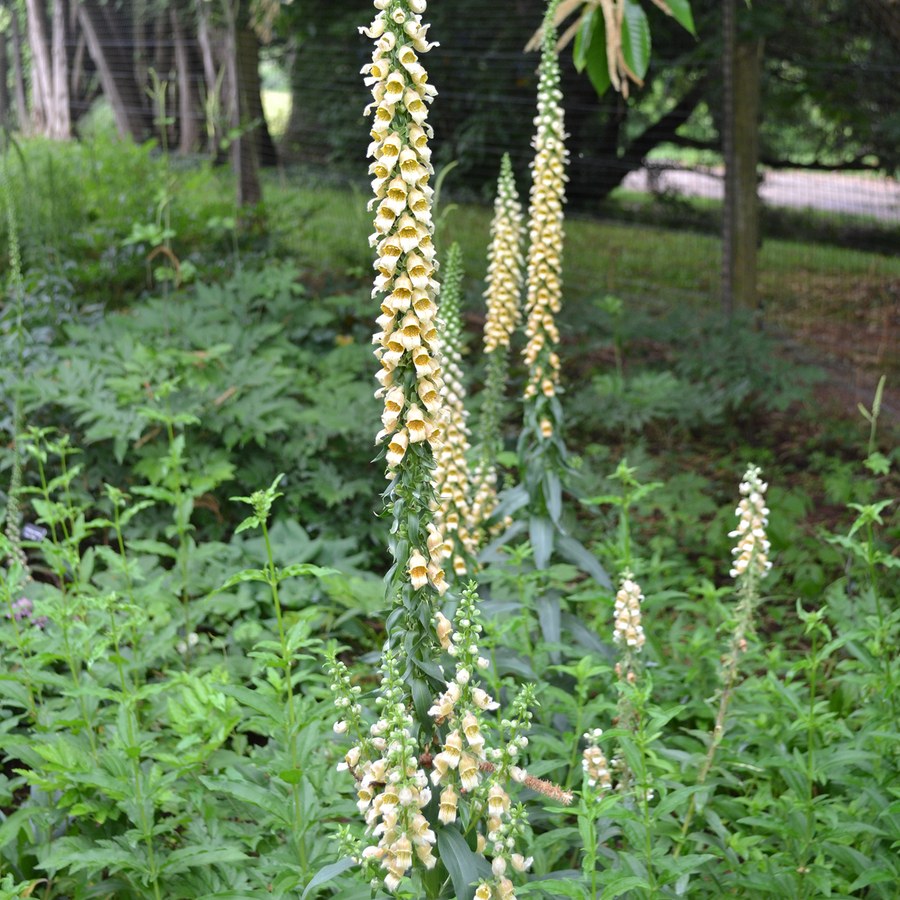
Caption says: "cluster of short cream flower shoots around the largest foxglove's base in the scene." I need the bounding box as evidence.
[330,584,573,900]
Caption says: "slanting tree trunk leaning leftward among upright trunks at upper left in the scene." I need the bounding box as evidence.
[78,0,152,141]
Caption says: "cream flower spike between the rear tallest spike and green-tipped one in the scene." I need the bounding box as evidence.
[472,153,525,546]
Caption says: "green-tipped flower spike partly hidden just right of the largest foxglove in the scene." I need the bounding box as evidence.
[432,244,477,577]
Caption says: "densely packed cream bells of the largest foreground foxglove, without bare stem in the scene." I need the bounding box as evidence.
[360,0,442,478]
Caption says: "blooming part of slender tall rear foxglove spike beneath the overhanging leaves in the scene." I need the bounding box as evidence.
[523,4,568,420]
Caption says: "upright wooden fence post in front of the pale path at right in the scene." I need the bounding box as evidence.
[732,40,763,309]
